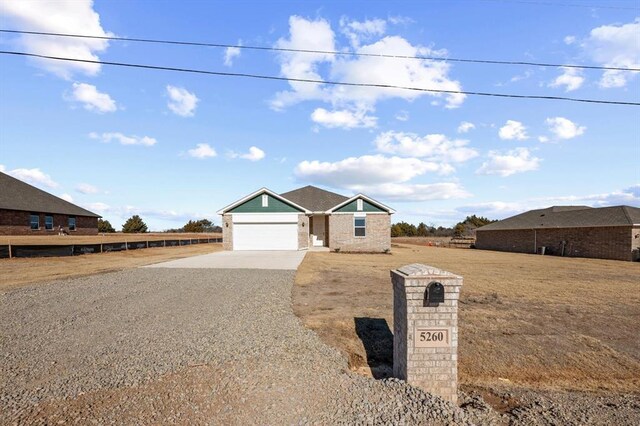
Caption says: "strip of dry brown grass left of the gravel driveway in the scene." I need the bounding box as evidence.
[0,241,222,292]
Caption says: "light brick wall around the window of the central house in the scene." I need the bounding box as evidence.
[328,213,391,252]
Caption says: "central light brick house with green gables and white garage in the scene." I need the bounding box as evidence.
[218,186,395,252]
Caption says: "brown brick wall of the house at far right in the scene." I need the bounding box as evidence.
[475,226,640,261]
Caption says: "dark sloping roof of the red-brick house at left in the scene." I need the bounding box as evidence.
[0,172,101,217]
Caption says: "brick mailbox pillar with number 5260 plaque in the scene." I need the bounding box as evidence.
[391,263,462,404]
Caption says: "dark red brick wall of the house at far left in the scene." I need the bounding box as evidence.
[0,209,98,235]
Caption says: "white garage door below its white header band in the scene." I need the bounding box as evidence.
[233,223,298,250]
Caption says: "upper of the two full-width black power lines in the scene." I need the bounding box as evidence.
[0,29,640,71]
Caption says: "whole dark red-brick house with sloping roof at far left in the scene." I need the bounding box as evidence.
[0,172,100,235]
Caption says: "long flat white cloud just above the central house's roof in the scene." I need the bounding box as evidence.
[294,155,453,188]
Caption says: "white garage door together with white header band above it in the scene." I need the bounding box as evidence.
[232,213,298,250]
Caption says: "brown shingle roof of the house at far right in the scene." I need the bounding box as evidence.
[476,206,640,232]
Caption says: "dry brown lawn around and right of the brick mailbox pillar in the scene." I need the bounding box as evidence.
[293,245,640,392]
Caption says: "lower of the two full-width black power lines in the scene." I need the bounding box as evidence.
[0,50,640,106]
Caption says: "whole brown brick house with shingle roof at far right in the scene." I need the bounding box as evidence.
[475,206,640,261]
